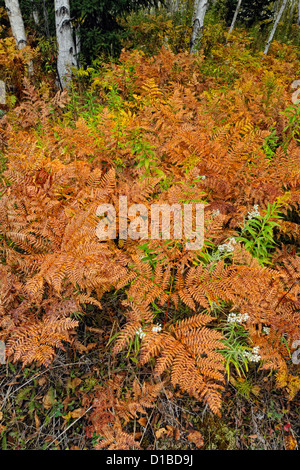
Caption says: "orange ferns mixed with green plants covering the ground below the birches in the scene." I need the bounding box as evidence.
[0,26,300,450]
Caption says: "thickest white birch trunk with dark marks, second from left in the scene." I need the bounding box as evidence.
[54,0,77,90]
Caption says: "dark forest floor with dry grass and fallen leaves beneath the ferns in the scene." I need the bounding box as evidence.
[0,310,300,450]
